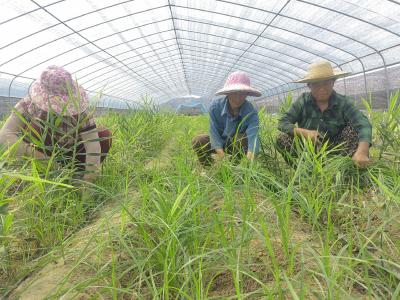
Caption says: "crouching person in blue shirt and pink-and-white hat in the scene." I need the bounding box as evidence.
[192,71,261,166]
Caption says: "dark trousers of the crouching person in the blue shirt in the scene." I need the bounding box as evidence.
[192,133,248,166]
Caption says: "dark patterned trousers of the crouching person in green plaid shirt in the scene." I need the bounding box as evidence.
[276,125,358,165]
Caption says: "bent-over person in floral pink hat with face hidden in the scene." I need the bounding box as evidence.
[0,66,111,181]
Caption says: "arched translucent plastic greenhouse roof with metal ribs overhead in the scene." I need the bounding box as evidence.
[0,0,400,103]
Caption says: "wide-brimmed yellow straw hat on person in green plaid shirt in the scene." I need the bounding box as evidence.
[295,60,350,83]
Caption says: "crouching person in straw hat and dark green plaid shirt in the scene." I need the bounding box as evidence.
[277,60,372,167]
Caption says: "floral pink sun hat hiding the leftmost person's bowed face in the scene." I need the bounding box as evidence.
[29,66,89,116]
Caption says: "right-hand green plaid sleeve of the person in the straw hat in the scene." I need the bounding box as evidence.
[343,100,372,144]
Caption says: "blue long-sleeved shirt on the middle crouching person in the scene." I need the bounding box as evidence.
[210,96,260,153]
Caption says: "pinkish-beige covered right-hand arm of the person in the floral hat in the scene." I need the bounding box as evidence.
[80,129,101,181]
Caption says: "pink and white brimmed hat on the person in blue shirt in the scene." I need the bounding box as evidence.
[215,71,261,97]
